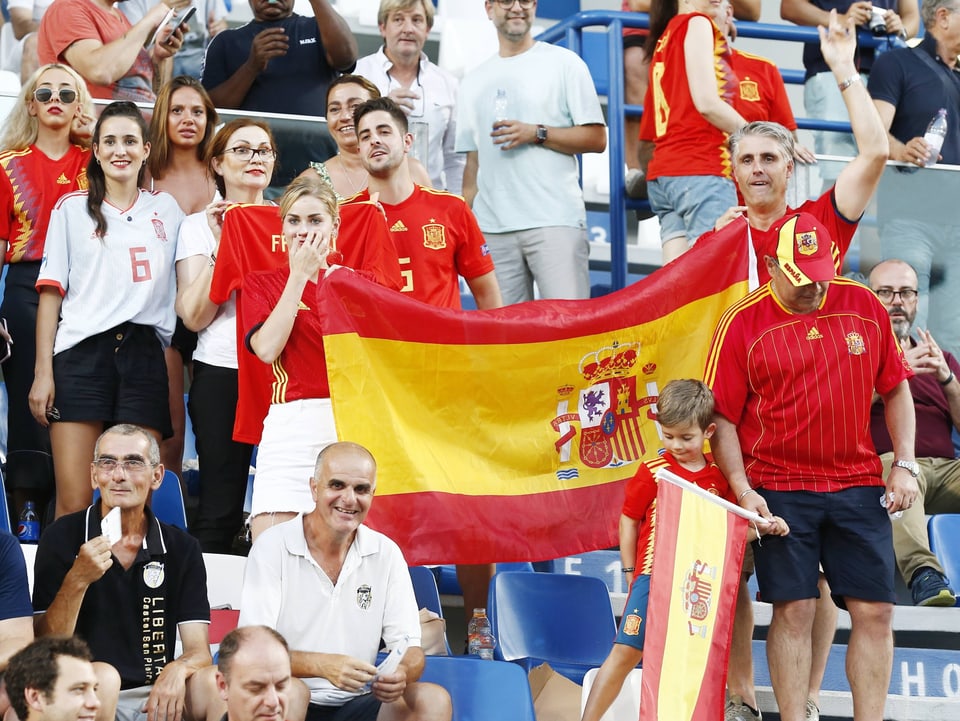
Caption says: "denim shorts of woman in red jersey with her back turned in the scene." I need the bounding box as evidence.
[647,175,737,245]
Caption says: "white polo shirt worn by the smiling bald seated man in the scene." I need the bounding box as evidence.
[239,514,420,706]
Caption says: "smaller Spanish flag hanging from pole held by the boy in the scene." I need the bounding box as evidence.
[640,470,747,721]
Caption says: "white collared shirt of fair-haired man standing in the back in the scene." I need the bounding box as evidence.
[354,45,467,195]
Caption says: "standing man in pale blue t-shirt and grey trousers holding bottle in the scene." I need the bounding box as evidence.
[457,0,607,305]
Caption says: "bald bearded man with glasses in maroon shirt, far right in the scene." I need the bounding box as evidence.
[870,260,960,606]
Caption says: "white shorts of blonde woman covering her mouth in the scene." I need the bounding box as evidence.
[250,398,337,518]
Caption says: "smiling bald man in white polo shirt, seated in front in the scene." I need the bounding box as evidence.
[240,442,452,721]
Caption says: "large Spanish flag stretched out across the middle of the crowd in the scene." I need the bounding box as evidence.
[318,228,749,564]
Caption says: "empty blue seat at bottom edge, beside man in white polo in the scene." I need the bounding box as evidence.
[420,656,536,721]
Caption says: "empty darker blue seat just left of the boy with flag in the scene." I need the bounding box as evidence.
[487,572,617,684]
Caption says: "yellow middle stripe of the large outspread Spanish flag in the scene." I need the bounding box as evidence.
[324,282,746,496]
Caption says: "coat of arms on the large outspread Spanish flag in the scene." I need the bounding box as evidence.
[551,342,657,478]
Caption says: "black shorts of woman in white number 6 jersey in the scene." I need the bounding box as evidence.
[53,323,173,438]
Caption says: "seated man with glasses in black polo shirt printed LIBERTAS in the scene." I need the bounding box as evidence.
[33,425,222,721]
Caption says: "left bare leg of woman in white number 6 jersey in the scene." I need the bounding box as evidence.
[50,421,103,516]
